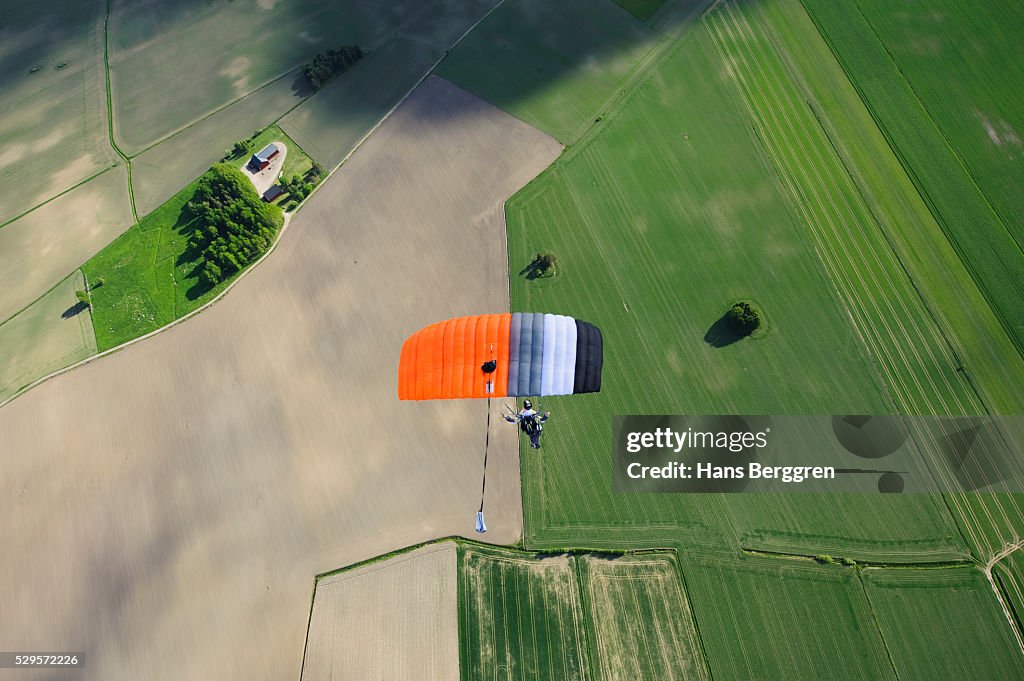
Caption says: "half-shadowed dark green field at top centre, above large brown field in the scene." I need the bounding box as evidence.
[437,0,657,143]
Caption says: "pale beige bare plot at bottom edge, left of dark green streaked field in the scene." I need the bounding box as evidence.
[302,542,459,681]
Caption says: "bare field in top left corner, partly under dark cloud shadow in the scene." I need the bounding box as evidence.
[0,0,118,224]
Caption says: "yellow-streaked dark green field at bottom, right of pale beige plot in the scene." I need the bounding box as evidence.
[459,544,710,681]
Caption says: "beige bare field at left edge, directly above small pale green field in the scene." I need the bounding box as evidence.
[0,166,132,322]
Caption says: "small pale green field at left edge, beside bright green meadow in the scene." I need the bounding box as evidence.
[0,271,96,402]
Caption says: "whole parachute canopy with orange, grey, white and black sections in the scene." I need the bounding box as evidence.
[398,312,603,399]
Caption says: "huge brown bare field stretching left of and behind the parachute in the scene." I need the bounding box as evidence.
[0,78,560,681]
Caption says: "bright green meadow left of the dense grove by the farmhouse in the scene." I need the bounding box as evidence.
[82,163,284,351]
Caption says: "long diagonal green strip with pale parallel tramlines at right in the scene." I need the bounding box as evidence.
[705,0,1024,555]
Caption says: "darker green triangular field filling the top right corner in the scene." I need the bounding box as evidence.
[805,0,1024,352]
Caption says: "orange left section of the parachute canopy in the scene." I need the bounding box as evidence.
[398,312,512,399]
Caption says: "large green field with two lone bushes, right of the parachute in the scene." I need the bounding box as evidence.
[506,6,966,560]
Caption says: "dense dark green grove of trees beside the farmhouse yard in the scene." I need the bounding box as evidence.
[188,163,284,288]
